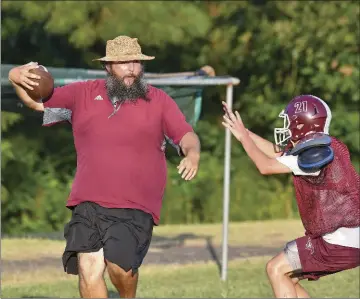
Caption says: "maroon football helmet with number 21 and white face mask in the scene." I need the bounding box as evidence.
[274,95,331,146]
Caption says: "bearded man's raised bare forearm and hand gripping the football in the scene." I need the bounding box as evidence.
[9,62,44,111]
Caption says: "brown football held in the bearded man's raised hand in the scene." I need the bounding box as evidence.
[26,65,54,101]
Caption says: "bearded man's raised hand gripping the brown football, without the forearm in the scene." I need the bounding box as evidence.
[9,62,40,90]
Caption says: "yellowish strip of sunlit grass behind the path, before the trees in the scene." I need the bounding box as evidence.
[1,220,304,260]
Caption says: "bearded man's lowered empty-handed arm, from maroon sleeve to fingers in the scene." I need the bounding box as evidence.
[163,93,200,180]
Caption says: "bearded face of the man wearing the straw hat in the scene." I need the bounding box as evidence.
[106,60,147,102]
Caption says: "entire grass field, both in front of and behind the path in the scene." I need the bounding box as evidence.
[1,220,359,298]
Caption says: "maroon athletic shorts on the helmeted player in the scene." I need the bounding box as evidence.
[284,236,360,280]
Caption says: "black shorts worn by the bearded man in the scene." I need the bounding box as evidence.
[62,202,154,275]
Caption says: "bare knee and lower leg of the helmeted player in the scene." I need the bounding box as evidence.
[266,252,310,298]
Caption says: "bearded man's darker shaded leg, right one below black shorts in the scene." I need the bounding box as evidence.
[106,261,139,298]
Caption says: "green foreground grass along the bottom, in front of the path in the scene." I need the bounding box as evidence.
[1,257,359,298]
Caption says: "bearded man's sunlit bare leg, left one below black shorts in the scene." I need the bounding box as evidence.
[78,249,108,298]
